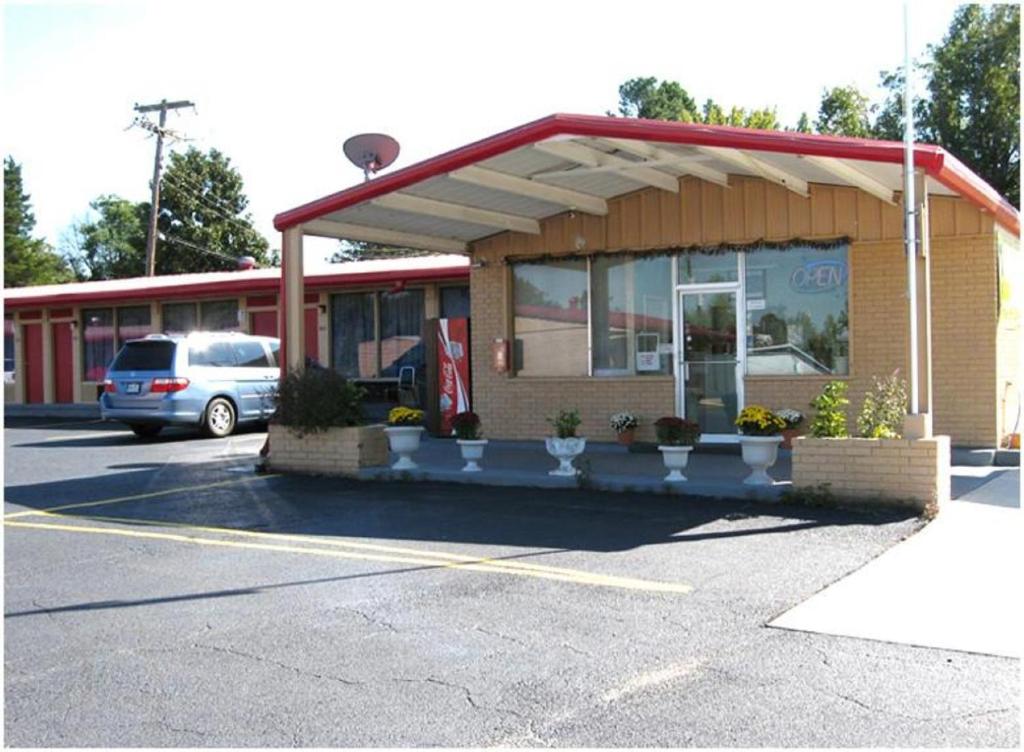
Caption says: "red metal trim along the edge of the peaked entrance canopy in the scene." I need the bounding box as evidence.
[273,114,1020,235]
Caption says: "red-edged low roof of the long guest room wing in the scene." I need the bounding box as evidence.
[3,255,469,309]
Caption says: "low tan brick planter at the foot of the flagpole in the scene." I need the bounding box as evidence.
[793,436,949,510]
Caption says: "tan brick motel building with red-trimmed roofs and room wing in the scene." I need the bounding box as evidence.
[4,115,1022,448]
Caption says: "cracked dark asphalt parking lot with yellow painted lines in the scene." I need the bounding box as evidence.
[4,420,1020,747]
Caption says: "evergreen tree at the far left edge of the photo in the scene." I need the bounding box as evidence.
[3,157,72,287]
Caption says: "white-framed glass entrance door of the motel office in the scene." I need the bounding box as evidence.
[679,287,742,441]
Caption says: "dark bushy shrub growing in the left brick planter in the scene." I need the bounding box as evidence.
[273,368,366,436]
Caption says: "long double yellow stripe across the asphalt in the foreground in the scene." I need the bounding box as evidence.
[4,514,692,594]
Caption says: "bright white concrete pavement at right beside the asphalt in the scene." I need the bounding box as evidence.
[769,468,1024,658]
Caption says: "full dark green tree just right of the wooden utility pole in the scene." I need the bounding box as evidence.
[152,148,270,275]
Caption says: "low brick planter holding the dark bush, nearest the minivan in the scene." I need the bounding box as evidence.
[269,423,388,475]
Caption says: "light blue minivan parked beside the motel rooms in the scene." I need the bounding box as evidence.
[99,332,281,436]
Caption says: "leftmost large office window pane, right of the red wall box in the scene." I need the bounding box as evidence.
[512,259,588,376]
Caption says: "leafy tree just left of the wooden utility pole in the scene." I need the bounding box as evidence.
[62,196,150,280]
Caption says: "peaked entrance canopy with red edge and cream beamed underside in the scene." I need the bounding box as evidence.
[274,115,1020,253]
